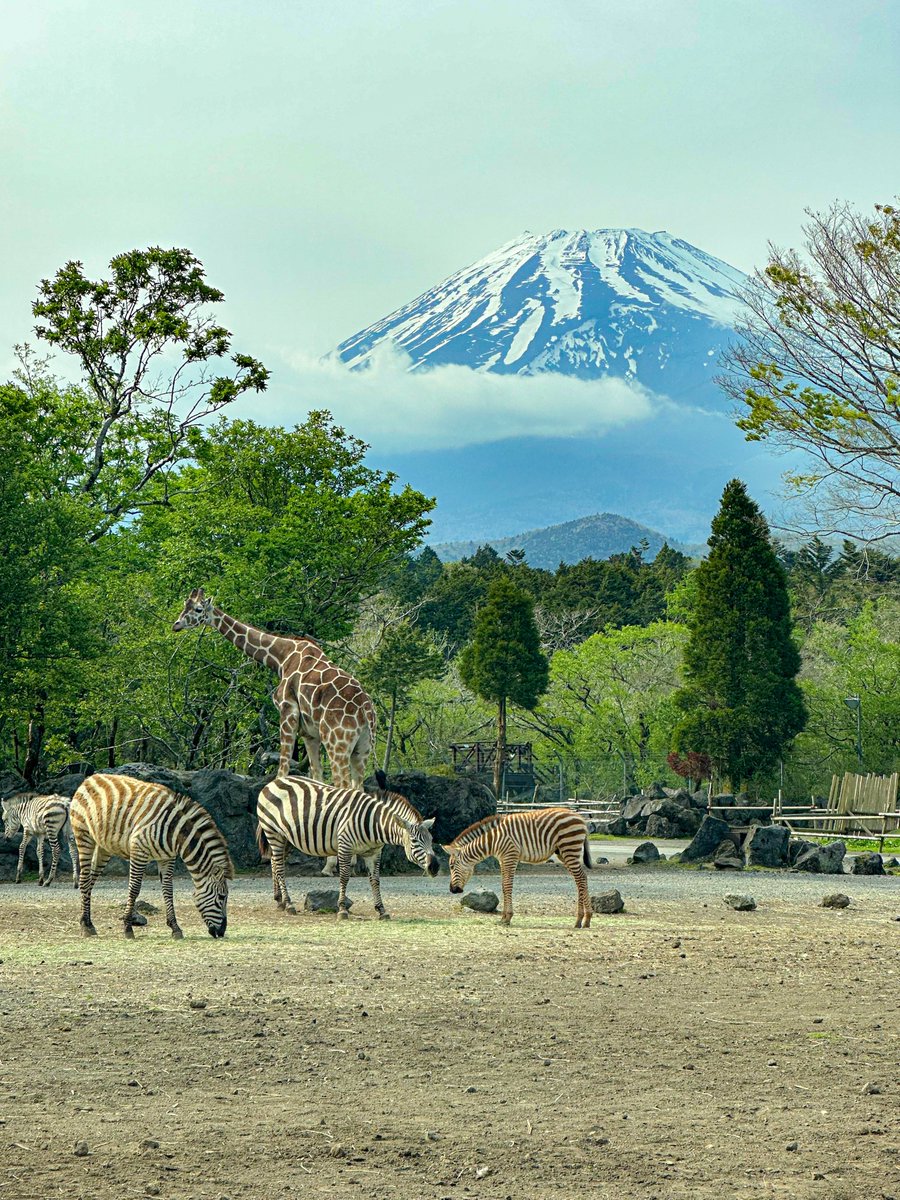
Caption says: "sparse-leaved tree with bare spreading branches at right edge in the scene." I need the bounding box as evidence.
[722,204,900,536]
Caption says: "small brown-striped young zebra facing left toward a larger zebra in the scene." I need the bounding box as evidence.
[444,809,593,929]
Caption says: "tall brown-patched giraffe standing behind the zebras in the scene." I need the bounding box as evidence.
[172,588,376,787]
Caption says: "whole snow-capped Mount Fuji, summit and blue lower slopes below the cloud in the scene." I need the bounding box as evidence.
[334,229,779,541]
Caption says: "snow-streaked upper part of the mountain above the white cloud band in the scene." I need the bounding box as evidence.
[337,229,745,400]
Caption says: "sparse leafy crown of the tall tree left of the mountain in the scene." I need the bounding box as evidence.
[32,246,269,540]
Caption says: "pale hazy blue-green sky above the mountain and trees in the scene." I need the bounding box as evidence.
[0,0,900,436]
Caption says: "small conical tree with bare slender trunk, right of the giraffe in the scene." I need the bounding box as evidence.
[460,575,548,799]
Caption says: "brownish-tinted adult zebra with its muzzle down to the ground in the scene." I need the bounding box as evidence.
[71,775,234,937]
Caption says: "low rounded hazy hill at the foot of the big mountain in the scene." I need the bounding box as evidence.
[431,512,700,571]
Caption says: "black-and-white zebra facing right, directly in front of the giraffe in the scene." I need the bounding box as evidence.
[257,776,438,918]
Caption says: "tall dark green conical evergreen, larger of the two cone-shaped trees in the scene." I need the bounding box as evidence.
[673,479,806,787]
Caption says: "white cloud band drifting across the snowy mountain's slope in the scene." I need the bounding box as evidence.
[260,346,658,451]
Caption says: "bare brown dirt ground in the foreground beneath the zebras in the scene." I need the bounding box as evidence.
[0,870,900,1200]
